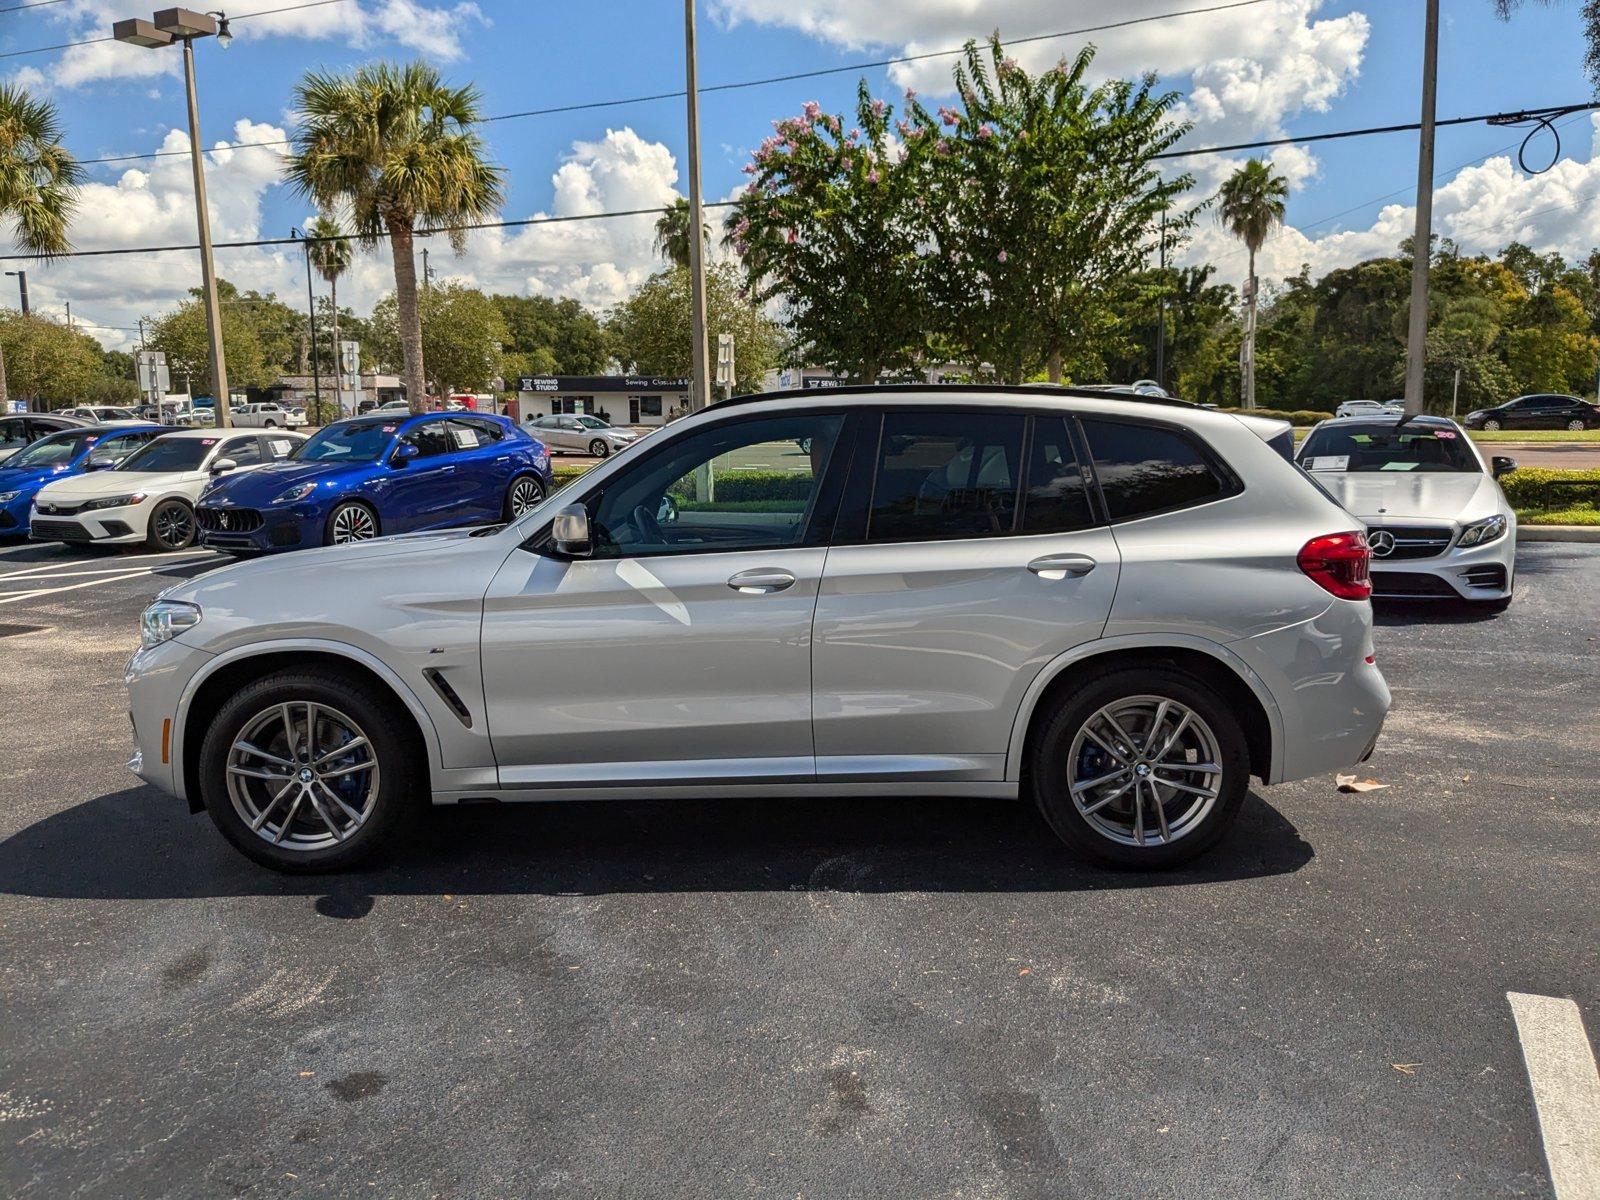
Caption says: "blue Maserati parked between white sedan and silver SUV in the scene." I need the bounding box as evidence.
[195,413,550,555]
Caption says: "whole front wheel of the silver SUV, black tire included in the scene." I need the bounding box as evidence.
[200,669,427,874]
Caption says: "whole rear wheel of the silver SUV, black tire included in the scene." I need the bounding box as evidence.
[1027,666,1250,870]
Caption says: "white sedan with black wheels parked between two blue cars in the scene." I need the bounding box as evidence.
[29,429,306,550]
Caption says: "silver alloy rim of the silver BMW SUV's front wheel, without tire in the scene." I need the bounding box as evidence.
[227,701,378,851]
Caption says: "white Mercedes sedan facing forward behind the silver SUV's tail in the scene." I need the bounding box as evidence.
[1298,414,1517,611]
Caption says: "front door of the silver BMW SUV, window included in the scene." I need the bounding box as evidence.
[482,413,843,789]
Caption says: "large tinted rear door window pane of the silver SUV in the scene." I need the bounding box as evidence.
[867,413,1024,542]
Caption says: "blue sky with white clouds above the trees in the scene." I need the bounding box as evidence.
[0,0,1600,341]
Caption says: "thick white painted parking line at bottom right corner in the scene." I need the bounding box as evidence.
[1506,992,1600,1200]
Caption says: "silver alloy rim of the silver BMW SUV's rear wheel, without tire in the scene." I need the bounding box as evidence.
[1067,696,1222,846]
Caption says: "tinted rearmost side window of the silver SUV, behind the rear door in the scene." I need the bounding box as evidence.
[1083,418,1227,520]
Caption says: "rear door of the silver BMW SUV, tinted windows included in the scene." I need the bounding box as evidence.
[811,408,1120,782]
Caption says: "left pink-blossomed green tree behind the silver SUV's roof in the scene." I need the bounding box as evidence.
[726,82,934,382]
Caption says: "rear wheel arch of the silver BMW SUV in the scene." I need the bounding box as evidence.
[1005,637,1283,793]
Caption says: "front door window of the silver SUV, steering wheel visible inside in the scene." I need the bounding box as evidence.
[592,414,843,558]
